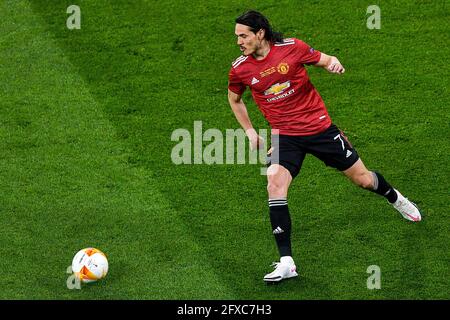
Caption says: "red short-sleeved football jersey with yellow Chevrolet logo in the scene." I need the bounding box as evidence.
[228,38,331,136]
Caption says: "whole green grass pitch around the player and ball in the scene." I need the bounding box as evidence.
[0,0,450,300]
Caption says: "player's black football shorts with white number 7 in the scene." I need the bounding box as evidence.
[267,124,359,178]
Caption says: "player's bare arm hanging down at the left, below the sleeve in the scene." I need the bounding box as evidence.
[228,89,264,150]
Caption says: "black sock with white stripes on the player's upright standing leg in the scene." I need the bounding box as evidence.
[269,198,292,257]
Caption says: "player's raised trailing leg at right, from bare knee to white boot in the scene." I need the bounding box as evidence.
[343,159,422,222]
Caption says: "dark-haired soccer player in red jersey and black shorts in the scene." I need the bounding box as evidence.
[228,11,421,283]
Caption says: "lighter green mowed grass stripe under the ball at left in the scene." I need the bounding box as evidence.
[0,1,233,299]
